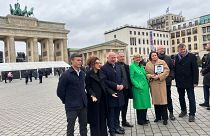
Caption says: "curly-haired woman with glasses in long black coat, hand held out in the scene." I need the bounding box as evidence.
[85,57,117,136]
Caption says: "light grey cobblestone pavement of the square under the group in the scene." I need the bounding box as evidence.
[0,77,210,136]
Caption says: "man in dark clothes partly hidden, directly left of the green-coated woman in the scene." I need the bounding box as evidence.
[117,52,133,127]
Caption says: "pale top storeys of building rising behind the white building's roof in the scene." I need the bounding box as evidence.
[147,13,185,31]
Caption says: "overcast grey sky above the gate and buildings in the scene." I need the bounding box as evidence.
[0,0,210,50]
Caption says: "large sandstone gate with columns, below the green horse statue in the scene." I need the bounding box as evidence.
[0,15,69,63]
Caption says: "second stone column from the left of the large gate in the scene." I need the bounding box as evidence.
[26,38,39,62]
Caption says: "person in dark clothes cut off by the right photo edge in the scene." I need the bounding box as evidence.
[199,43,210,110]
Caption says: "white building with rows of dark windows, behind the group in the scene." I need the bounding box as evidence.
[104,25,171,64]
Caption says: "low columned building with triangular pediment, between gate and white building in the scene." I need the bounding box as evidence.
[68,39,128,65]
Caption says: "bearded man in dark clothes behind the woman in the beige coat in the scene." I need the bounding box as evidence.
[157,45,175,120]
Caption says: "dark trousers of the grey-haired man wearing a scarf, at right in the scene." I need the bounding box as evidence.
[177,88,196,116]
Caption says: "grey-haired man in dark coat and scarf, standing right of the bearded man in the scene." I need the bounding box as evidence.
[175,44,199,122]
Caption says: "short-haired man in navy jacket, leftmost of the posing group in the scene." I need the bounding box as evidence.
[57,54,87,136]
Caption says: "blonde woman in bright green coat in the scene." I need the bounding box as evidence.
[130,54,151,125]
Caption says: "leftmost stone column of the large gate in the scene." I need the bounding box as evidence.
[4,36,16,63]
